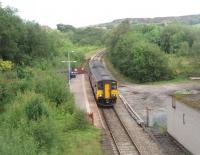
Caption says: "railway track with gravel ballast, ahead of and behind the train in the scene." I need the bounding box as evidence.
[91,49,162,155]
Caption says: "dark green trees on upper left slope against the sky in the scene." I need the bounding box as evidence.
[0,7,67,64]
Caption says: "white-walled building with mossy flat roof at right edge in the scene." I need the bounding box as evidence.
[167,92,200,155]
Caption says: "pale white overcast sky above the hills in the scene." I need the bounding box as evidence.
[0,0,200,28]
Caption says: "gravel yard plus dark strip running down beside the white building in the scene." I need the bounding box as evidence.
[119,82,200,155]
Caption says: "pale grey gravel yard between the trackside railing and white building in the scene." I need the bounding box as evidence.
[119,82,200,127]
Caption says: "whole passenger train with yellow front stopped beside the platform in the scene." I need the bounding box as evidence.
[88,60,118,106]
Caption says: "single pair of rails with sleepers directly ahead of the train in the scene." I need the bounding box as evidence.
[102,107,141,155]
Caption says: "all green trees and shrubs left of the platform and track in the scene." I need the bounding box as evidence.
[0,6,102,155]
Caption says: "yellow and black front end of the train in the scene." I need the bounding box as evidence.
[96,80,118,106]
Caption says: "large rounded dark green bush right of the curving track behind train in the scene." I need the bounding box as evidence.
[109,33,172,82]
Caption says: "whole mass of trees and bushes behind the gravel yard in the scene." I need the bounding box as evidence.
[108,21,200,82]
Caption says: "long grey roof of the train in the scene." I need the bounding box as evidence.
[89,60,115,81]
